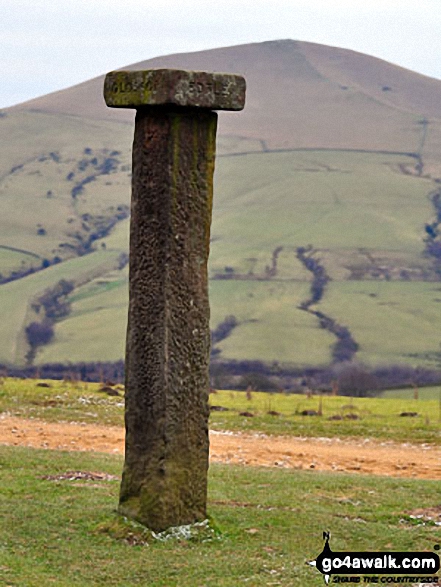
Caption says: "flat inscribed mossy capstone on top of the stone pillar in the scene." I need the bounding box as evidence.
[104,69,245,110]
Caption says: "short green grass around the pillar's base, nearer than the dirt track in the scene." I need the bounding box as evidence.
[0,447,439,587]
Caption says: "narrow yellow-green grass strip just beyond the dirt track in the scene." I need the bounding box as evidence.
[0,378,441,445]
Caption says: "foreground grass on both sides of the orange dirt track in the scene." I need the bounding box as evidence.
[0,379,441,587]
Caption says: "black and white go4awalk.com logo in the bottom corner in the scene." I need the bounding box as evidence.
[308,532,440,585]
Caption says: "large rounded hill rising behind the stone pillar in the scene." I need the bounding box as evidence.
[0,40,441,366]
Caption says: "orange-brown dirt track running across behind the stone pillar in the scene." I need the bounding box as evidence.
[0,416,441,479]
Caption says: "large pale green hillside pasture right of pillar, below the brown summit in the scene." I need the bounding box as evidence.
[211,151,433,272]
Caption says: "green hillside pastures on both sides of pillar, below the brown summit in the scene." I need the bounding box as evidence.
[0,112,441,367]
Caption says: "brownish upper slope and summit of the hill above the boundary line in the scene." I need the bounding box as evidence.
[8,40,441,176]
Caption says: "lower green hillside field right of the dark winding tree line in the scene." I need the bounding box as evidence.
[317,281,441,368]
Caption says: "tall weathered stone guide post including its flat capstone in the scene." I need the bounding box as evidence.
[104,69,245,531]
